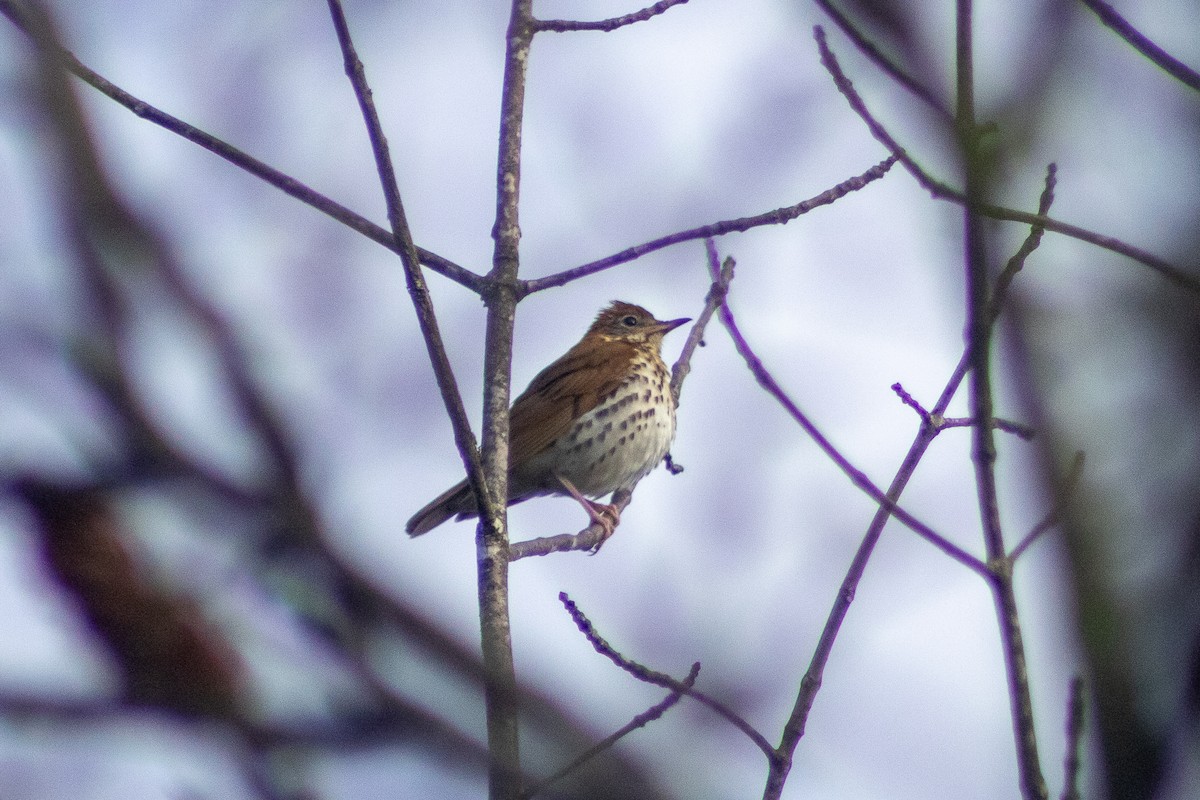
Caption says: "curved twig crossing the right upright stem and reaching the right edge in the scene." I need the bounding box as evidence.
[814,25,1200,294]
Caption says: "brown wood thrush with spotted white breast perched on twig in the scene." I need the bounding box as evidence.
[407,301,690,536]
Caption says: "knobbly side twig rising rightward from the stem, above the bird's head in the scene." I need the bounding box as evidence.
[521,156,896,295]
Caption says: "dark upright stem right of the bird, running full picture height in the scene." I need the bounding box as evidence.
[955,0,1046,800]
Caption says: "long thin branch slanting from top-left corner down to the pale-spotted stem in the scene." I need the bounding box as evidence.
[0,0,482,291]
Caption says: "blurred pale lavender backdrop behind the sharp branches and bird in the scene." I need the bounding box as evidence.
[0,0,1200,800]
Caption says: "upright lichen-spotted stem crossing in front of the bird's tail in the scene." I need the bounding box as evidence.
[476,0,534,800]
